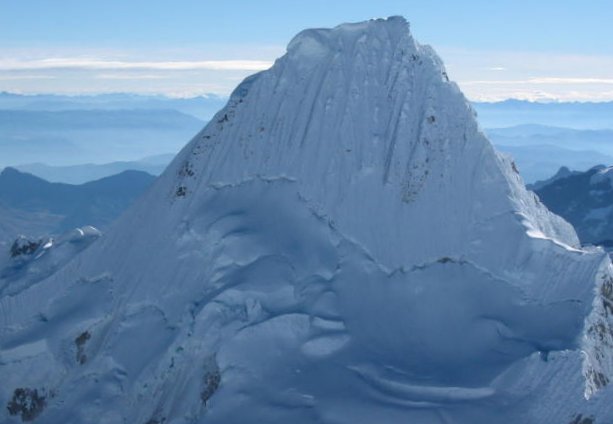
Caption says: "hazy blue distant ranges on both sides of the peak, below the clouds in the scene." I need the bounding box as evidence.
[0,93,613,184]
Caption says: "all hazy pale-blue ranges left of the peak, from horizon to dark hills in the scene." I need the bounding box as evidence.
[0,93,226,169]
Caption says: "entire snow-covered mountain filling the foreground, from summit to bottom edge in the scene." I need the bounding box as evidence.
[0,17,613,424]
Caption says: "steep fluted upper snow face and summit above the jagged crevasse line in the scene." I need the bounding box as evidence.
[165,14,578,269]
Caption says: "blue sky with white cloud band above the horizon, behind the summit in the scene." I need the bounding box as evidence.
[0,0,613,101]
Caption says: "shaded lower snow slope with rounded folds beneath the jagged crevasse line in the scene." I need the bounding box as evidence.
[3,179,583,423]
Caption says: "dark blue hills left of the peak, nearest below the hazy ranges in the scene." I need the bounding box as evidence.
[0,168,155,240]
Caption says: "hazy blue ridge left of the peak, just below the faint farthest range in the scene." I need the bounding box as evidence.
[0,110,204,166]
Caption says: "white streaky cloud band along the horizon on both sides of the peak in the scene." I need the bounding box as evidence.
[0,47,613,101]
